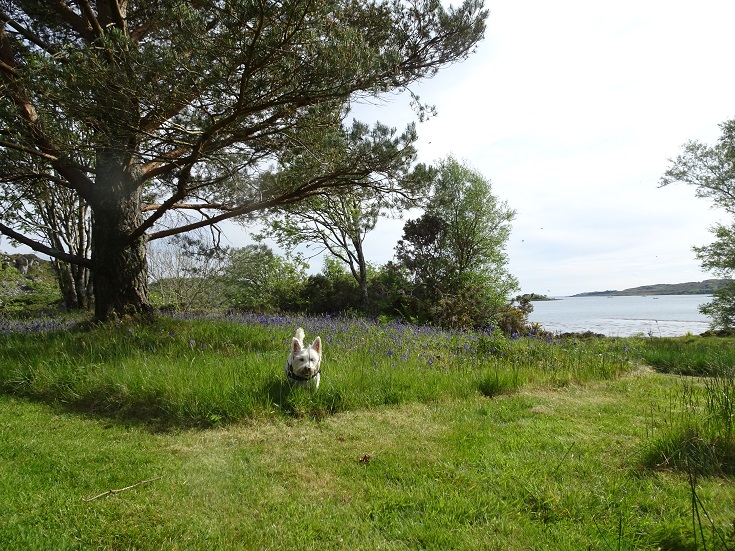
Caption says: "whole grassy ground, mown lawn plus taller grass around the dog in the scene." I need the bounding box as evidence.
[0,312,735,550]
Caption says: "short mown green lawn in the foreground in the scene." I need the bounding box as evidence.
[0,375,735,550]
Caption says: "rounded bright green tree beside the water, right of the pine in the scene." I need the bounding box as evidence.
[396,157,518,326]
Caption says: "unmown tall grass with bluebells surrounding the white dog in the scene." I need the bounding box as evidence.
[0,314,637,426]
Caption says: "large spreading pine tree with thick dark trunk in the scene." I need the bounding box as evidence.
[0,0,486,319]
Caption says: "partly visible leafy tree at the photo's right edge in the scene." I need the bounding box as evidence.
[660,119,735,331]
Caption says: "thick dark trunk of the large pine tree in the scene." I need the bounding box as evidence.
[89,151,150,320]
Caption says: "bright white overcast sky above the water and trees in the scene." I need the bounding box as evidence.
[2,0,735,296]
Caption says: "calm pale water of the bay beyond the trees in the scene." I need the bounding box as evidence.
[528,295,712,337]
